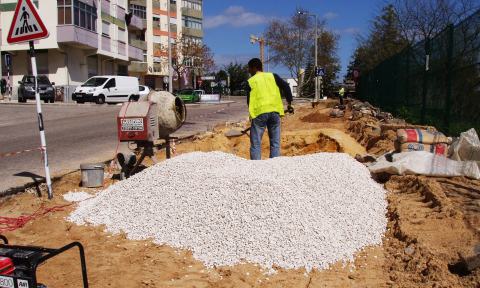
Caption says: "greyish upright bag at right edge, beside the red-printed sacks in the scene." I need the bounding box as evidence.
[450,128,480,167]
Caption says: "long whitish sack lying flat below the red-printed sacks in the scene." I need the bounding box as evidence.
[368,151,480,180]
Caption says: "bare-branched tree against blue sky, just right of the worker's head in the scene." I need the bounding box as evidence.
[265,9,324,96]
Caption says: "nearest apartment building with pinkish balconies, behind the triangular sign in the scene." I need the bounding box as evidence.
[0,0,145,98]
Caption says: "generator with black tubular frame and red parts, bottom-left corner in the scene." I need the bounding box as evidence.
[0,235,88,288]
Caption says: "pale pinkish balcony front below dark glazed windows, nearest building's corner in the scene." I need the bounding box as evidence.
[57,25,98,49]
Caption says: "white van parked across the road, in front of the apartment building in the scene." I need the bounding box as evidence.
[72,76,140,104]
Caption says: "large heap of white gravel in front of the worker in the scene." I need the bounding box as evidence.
[69,152,387,271]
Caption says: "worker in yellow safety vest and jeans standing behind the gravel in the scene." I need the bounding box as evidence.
[247,58,294,160]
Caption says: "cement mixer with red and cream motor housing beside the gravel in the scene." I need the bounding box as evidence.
[117,91,187,178]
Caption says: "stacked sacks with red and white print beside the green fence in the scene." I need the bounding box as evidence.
[397,129,452,156]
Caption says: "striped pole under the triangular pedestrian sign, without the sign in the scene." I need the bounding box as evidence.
[29,41,53,199]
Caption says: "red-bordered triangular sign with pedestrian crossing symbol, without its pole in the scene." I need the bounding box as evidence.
[7,0,48,44]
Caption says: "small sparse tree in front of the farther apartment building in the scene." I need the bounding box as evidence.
[168,35,215,89]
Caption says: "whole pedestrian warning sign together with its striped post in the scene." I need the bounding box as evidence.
[7,0,53,199]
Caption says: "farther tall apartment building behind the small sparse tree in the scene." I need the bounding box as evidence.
[128,0,203,89]
